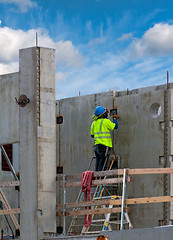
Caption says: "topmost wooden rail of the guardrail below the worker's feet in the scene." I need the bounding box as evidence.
[57,168,173,181]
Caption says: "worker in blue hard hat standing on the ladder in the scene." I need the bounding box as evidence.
[91,106,118,171]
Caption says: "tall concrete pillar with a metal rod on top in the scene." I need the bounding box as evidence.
[19,47,56,240]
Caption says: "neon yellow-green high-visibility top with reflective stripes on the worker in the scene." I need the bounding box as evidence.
[91,118,115,147]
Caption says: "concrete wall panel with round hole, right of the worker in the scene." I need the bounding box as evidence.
[116,89,164,228]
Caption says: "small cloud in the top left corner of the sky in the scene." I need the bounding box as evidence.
[0,0,37,12]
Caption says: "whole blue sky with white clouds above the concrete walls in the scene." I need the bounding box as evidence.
[0,0,173,99]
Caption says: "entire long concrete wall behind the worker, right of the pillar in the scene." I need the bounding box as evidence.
[57,85,173,228]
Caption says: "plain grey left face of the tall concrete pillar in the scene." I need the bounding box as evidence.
[19,48,38,240]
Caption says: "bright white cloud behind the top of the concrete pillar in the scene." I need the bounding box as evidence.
[0,27,83,67]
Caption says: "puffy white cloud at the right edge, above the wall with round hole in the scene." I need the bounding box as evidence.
[130,23,173,58]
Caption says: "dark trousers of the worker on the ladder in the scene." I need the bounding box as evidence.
[94,144,111,171]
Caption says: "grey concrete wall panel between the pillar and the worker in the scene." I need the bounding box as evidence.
[56,91,114,231]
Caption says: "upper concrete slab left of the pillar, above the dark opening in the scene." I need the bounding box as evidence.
[0,73,19,144]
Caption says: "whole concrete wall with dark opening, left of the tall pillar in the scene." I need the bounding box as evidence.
[0,73,19,235]
